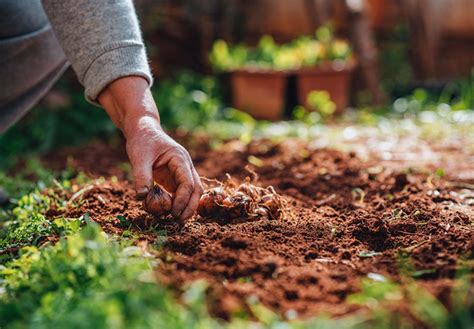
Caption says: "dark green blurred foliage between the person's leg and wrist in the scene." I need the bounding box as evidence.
[0,77,116,169]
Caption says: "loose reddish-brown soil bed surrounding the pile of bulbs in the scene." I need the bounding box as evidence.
[43,140,474,318]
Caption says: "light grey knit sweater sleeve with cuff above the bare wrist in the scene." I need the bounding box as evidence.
[43,0,153,105]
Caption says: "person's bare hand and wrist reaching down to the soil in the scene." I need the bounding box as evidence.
[99,76,203,221]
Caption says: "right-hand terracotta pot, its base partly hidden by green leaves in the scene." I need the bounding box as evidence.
[296,61,355,114]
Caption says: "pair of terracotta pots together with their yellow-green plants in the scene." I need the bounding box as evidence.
[210,26,354,120]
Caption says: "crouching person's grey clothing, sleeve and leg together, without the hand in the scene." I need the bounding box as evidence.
[0,0,152,133]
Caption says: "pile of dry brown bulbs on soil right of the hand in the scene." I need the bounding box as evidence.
[197,175,284,223]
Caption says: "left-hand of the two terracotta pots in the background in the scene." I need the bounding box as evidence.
[230,70,287,120]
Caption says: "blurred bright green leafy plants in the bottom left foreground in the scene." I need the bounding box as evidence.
[0,224,217,328]
